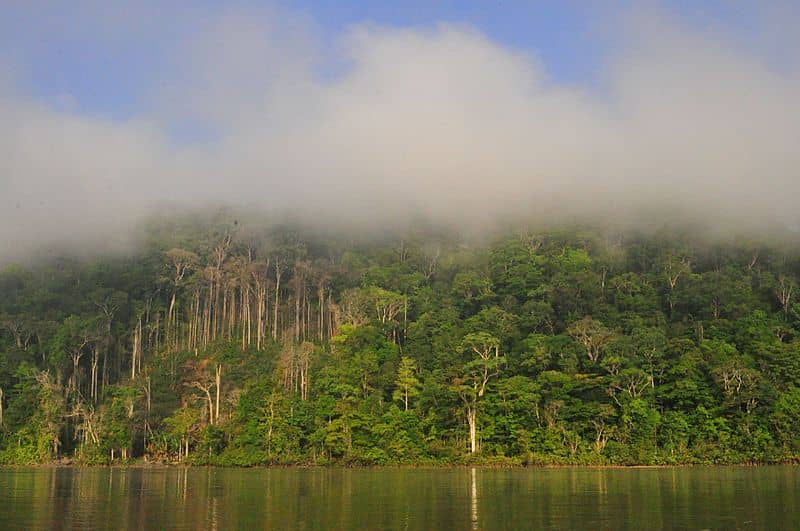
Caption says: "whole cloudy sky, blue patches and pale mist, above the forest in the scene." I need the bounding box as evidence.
[0,0,800,256]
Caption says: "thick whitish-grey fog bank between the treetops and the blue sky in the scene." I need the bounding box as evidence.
[0,3,800,257]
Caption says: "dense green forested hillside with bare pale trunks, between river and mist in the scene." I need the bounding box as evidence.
[0,214,800,466]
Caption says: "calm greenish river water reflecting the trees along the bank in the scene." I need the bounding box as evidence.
[0,466,800,530]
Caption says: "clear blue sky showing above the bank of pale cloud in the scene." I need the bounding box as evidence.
[0,0,791,118]
